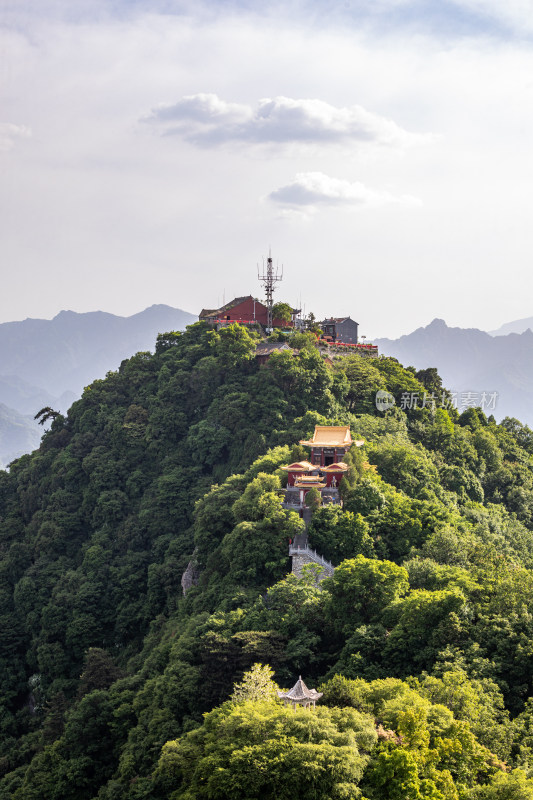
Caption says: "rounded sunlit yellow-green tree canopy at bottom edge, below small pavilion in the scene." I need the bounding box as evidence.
[156,701,376,800]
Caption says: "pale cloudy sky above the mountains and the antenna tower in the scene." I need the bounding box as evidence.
[0,0,533,340]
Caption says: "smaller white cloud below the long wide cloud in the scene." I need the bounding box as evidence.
[269,172,420,208]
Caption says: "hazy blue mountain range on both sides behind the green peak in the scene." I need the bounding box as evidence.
[4,305,533,468]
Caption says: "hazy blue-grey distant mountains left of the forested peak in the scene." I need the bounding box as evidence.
[0,305,198,465]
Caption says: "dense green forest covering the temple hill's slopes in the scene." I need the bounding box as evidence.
[0,323,533,800]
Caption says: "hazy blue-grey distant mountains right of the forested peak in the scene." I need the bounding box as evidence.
[374,319,533,426]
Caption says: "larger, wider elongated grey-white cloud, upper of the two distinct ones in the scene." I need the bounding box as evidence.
[145,94,427,146]
